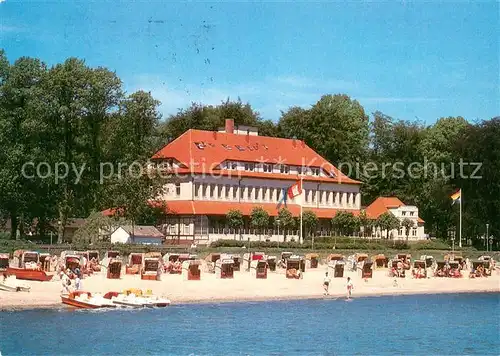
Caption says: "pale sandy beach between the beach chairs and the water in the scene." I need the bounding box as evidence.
[0,265,500,310]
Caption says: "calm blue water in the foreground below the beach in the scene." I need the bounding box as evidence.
[0,294,500,356]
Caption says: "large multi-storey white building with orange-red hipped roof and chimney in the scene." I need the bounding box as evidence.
[152,120,361,244]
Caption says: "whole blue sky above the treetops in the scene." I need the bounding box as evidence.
[0,0,500,124]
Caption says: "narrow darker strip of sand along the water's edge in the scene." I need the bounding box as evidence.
[0,287,500,312]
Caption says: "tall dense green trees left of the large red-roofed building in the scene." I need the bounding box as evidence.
[0,51,167,240]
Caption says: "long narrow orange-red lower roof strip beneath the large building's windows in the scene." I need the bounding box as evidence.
[160,200,359,218]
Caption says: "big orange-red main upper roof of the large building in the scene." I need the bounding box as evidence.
[152,129,360,184]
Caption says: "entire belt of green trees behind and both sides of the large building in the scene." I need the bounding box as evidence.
[0,51,500,248]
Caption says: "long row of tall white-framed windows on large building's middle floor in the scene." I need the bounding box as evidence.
[194,183,359,207]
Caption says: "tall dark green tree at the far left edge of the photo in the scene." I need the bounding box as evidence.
[0,56,47,238]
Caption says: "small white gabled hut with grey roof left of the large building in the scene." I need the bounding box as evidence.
[111,225,165,245]
